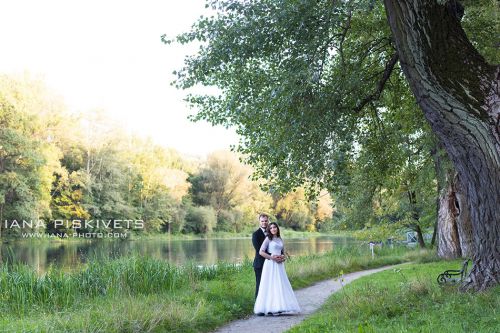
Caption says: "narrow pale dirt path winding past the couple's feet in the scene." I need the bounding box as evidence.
[215,266,394,333]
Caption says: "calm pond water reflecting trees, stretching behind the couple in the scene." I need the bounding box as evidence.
[0,236,354,272]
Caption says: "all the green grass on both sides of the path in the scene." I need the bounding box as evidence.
[0,246,486,332]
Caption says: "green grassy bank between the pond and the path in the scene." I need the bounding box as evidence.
[0,246,442,332]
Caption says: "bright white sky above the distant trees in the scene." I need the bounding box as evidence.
[0,0,238,156]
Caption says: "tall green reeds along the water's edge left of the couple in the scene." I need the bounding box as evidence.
[0,256,241,316]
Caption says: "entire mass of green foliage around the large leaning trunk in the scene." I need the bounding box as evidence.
[169,0,499,239]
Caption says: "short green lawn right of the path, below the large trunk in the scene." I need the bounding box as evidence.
[288,261,500,333]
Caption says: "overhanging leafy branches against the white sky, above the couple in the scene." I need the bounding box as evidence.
[172,1,393,192]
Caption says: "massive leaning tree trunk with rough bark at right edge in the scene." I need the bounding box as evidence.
[384,0,500,290]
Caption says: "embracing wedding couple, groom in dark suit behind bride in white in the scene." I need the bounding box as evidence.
[252,214,300,316]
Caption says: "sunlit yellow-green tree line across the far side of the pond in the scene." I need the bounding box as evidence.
[0,75,333,237]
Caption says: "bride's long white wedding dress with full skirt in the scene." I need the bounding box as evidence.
[253,237,300,314]
